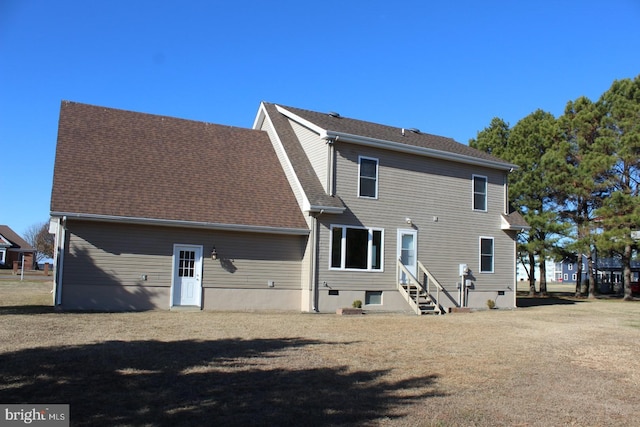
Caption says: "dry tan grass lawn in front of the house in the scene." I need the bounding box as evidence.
[0,279,640,426]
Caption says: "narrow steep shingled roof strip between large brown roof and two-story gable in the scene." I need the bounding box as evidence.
[263,102,344,210]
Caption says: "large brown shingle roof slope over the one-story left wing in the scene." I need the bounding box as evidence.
[51,101,308,232]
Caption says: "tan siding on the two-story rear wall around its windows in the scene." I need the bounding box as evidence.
[319,143,515,300]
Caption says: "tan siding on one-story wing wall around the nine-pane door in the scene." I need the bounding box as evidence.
[62,221,307,309]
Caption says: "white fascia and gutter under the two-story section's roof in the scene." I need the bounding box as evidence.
[321,130,518,171]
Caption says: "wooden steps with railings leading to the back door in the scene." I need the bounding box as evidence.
[397,259,444,316]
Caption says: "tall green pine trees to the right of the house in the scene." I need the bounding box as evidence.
[469,75,640,300]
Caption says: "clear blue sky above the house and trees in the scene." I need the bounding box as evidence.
[0,0,640,239]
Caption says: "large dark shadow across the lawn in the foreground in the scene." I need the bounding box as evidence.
[0,338,442,426]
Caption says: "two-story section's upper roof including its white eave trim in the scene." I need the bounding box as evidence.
[279,106,517,170]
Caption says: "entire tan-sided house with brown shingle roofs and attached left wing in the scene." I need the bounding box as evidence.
[51,102,528,314]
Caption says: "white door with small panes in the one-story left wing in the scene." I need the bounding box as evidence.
[172,245,202,307]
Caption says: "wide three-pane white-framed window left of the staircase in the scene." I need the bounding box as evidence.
[329,225,384,271]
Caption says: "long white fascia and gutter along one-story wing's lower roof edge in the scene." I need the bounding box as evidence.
[51,212,309,236]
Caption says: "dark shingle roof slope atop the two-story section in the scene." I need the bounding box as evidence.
[281,106,514,168]
